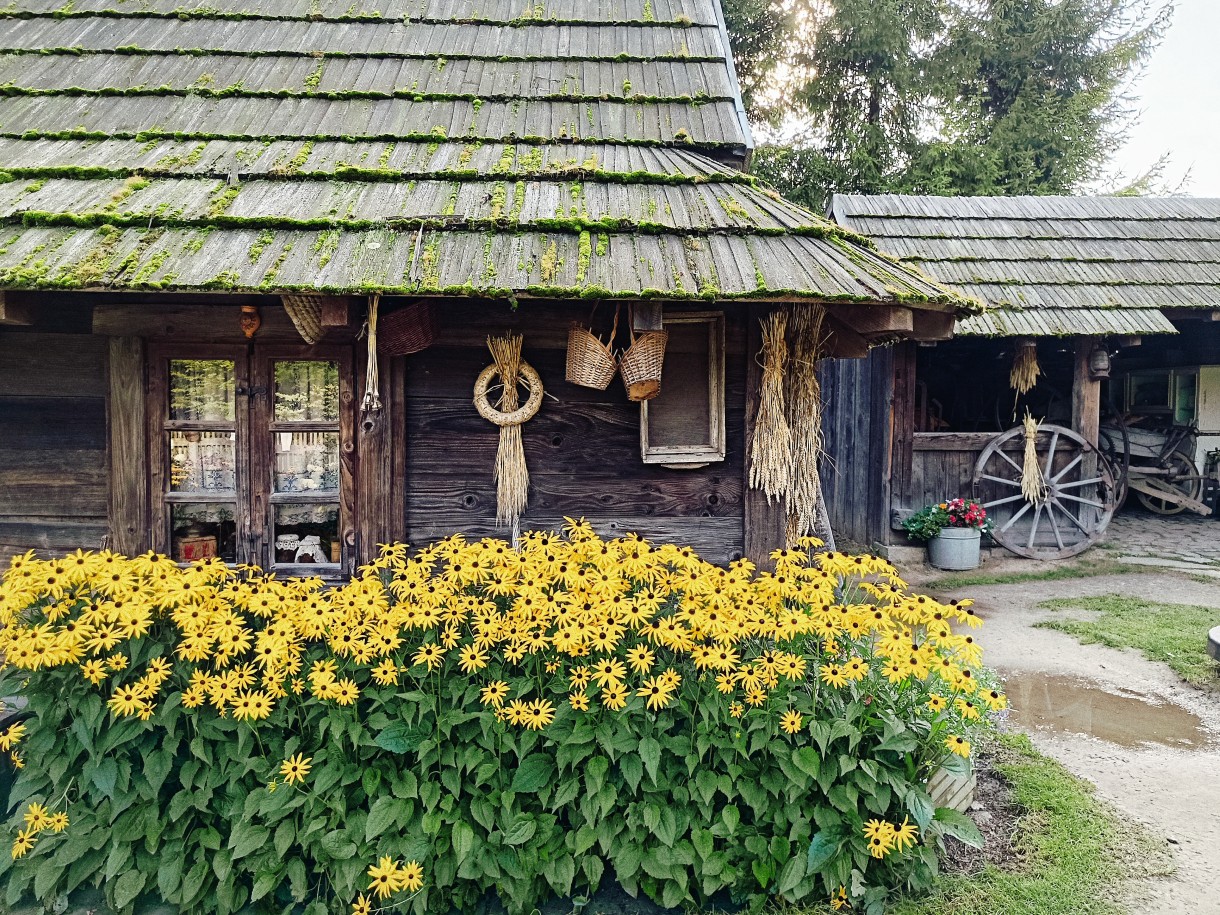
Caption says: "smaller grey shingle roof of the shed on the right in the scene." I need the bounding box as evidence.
[831,194,1220,336]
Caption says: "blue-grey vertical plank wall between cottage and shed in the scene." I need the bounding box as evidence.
[820,348,894,548]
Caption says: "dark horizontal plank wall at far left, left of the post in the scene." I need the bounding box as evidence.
[0,327,109,561]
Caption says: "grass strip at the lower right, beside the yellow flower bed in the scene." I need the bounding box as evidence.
[878,734,1169,915]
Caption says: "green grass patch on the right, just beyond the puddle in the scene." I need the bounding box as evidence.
[1036,594,1220,686]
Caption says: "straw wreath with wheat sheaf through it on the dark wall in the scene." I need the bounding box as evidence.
[475,334,543,528]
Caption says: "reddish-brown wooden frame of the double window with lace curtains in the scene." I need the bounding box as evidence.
[146,343,356,578]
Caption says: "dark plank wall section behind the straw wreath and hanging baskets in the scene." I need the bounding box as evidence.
[406,301,745,562]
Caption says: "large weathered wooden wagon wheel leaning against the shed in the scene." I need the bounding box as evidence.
[974,426,1114,559]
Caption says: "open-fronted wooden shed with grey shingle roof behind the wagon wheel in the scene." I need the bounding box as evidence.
[824,195,1220,555]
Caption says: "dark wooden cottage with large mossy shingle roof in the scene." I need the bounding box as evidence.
[0,0,961,575]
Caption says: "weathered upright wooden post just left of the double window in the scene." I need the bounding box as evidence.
[106,337,151,556]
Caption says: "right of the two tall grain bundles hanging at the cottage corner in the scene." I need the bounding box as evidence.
[787,305,826,544]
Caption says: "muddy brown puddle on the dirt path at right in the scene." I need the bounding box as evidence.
[1004,672,1208,749]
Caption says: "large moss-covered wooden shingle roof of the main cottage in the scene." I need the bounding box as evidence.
[0,0,961,310]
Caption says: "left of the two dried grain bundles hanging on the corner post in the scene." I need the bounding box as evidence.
[750,310,793,504]
